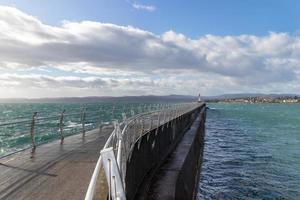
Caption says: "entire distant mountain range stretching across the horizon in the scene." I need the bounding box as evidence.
[0,93,300,103]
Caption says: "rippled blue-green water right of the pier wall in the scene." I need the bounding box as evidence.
[197,103,300,200]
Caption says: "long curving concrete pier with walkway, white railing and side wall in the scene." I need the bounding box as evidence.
[0,102,205,200]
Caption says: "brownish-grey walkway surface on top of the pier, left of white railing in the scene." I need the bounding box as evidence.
[0,127,112,200]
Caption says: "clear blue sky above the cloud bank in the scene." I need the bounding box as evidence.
[0,0,300,38]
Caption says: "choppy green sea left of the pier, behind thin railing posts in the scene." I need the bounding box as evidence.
[0,102,166,157]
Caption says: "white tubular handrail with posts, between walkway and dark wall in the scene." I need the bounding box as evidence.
[85,103,199,200]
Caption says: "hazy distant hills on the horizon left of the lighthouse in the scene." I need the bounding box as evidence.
[0,95,197,103]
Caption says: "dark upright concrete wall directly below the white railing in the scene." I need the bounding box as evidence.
[125,104,205,199]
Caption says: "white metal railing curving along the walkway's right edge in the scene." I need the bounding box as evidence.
[85,103,199,200]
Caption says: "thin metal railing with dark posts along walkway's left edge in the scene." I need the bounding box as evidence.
[0,104,176,158]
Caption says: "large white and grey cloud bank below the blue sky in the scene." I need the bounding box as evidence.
[0,4,300,97]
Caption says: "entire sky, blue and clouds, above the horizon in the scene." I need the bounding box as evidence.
[0,0,300,98]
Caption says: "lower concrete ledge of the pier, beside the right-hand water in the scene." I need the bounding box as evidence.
[145,109,204,200]
